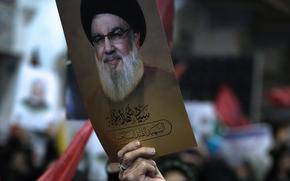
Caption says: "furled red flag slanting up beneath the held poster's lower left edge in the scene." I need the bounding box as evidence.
[38,121,93,181]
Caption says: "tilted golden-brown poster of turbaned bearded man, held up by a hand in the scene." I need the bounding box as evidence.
[57,0,196,161]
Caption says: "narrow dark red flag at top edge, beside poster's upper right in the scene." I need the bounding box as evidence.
[157,0,174,48]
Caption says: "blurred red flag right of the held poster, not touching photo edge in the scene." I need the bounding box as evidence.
[215,86,249,127]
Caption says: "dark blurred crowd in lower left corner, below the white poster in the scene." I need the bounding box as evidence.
[0,125,59,180]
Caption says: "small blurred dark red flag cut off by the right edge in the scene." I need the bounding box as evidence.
[267,86,290,107]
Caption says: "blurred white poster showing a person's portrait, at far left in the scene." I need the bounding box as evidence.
[11,64,63,131]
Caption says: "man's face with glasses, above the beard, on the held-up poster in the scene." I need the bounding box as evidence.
[91,14,139,71]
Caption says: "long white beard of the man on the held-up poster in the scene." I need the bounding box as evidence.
[96,45,144,102]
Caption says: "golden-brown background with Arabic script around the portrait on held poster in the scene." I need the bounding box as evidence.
[56,0,196,161]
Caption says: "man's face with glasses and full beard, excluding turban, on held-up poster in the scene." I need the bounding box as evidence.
[91,14,144,101]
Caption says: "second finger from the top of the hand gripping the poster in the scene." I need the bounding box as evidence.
[121,147,156,167]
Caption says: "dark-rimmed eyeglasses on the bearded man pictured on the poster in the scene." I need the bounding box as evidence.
[92,27,130,48]
